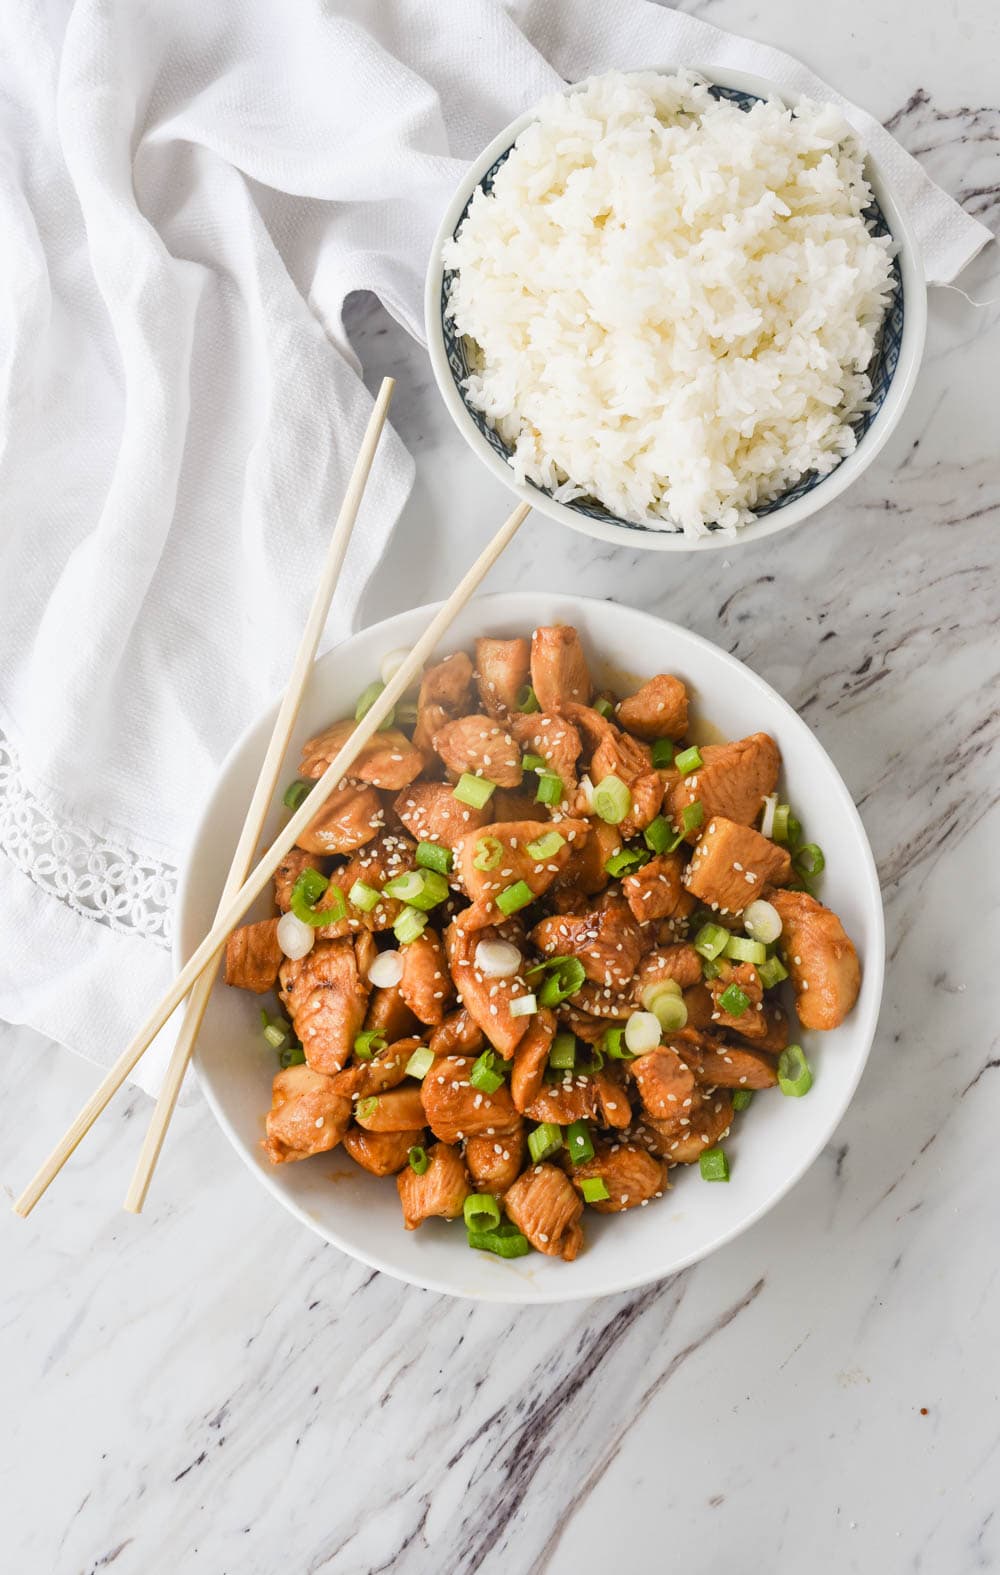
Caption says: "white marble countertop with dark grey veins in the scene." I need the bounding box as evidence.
[0,0,1000,1575]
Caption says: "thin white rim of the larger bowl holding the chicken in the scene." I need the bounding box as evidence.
[172,591,885,1306]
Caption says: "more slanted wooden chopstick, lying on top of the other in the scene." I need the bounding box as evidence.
[14,502,531,1217]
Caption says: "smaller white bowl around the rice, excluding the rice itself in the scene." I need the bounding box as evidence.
[424,66,928,553]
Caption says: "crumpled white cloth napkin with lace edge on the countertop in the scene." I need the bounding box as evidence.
[0,0,987,1087]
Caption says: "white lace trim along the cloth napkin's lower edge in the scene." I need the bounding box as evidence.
[0,731,176,947]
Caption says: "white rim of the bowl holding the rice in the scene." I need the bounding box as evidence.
[424,65,928,553]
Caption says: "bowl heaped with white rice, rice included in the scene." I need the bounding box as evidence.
[425,69,926,551]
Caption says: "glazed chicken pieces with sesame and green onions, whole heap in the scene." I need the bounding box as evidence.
[225,625,861,1262]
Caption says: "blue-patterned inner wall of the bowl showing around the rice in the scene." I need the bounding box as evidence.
[431,72,906,545]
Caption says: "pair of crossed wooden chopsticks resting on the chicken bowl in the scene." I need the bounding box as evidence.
[14,378,531,1217]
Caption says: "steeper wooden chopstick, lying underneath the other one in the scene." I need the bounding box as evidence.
[124,378,395,1214]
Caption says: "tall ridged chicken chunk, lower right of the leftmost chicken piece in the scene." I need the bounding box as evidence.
[279,940,369,1073]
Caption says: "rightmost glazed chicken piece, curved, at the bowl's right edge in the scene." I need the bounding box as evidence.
[769,891,861,1030]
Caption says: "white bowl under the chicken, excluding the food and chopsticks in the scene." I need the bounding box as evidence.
[175,592,883,1303]
